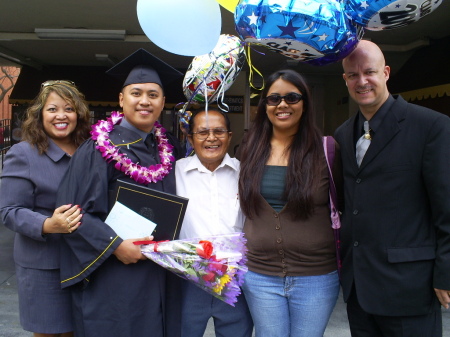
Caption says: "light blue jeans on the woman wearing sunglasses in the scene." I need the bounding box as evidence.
[242,271,339,337]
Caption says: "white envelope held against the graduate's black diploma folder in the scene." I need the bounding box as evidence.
[105,201,156,240]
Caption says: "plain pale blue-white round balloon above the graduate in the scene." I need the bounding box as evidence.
[136,0,222,56]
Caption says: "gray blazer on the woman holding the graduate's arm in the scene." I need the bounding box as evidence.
[0,139,70,269]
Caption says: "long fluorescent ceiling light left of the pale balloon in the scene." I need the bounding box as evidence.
[34,28,126,40]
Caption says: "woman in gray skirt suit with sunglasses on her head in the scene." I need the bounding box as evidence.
[0,80,89,337]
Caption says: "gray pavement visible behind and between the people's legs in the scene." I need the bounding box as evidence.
[0,220,450,337]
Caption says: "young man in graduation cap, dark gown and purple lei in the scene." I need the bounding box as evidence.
[57,49,182,337]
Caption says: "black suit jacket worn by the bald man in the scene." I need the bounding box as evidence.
[335,97,450,316]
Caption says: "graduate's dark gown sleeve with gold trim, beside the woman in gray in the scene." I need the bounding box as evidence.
[57,140,123,288]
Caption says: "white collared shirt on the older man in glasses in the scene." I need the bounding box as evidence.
[175,154,244,239]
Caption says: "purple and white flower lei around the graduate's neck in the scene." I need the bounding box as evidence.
[91,111,175,184]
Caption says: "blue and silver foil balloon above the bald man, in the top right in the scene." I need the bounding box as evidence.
[345,0,442,31]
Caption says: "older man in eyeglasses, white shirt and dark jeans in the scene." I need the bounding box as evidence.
[175,110,253,337]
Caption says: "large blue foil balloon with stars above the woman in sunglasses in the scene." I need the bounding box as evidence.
[235,0,363,65]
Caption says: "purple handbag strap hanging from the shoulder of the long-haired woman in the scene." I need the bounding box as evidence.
[323,136,342,277]
